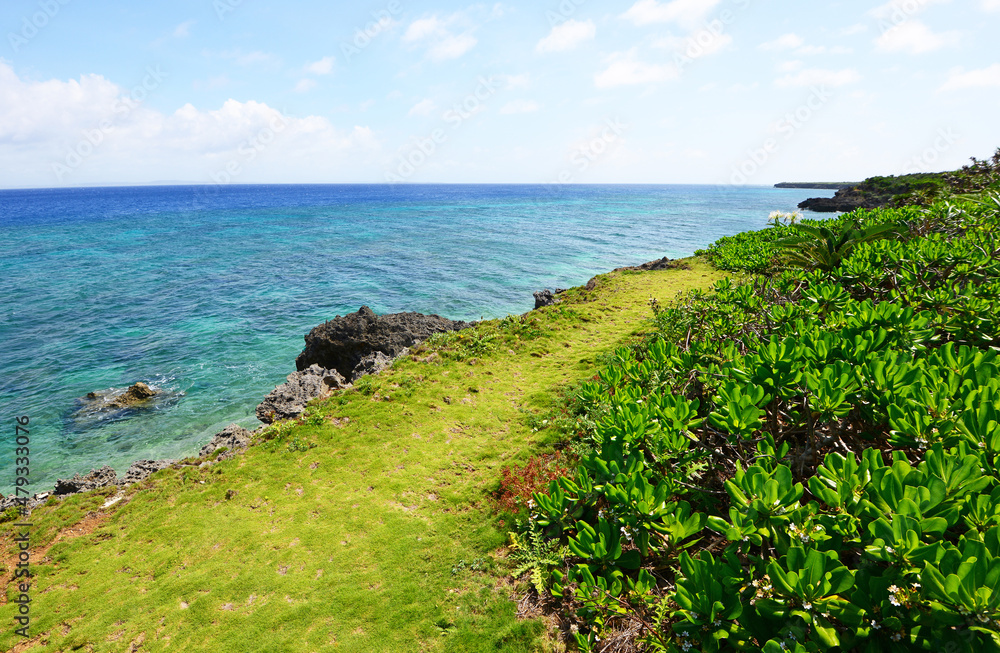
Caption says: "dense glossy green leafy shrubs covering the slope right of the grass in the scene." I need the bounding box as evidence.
[500,152,1000,653]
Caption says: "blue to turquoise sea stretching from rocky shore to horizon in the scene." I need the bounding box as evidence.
[0,185,832,493]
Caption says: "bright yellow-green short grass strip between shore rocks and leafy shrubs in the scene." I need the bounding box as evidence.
[0,262,720,652]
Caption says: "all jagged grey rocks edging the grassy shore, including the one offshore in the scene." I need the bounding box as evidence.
[0,258,687,513]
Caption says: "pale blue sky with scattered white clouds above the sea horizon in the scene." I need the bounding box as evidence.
[0,0,1000,188]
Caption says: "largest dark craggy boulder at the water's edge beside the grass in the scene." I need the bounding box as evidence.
[295,306,472,379]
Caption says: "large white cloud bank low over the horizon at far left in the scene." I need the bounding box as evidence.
[0,61,380,186]
